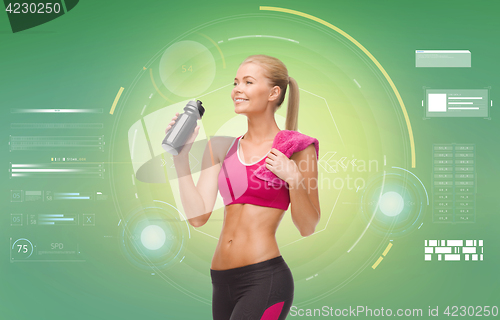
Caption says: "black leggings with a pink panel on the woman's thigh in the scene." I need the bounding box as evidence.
[210,256,294,320]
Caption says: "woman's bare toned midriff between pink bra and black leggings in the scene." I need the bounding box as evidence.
[211,203,285,270]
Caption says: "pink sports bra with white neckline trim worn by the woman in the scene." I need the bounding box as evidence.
[218,136,290,210]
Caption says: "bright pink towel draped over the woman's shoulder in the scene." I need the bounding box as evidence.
[254,130,319,186]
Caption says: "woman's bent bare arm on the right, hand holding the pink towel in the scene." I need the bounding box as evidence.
[267,144,321,237]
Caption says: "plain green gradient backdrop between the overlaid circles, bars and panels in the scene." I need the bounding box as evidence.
[0,0,500,319]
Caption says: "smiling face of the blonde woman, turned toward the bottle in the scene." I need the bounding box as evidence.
[231,62,279,114]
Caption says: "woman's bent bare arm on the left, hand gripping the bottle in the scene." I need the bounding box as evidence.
[165,113,221,227]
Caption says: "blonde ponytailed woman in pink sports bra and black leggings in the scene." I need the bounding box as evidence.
[166,55,320,320]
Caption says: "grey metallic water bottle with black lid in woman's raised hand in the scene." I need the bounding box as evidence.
[162,100,205,156]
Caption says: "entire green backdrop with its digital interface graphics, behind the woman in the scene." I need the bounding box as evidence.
[0,0,500,320]
